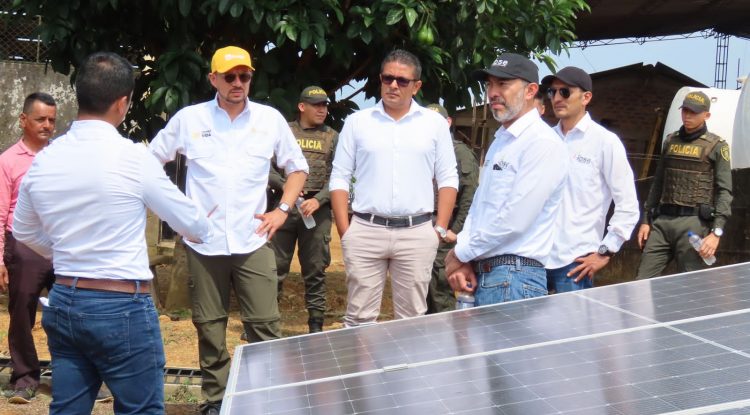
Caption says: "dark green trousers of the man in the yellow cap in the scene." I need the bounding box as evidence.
[186,245,281,402]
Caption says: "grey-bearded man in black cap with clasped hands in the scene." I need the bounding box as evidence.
[446,53,568,305]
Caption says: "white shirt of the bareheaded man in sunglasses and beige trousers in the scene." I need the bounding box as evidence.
[329,100,458,216]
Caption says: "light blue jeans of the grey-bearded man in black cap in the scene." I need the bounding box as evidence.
[474,264,547,306]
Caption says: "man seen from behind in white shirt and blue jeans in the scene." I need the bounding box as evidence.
[13,52,211,415]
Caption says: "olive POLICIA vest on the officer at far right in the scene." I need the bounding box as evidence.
[660,132,721,207]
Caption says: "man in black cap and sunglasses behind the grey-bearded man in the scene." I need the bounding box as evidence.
[542,66,639,293]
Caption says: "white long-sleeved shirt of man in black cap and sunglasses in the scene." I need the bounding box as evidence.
[547,113,640,268]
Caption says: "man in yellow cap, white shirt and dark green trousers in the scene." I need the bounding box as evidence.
[150,46,308,414]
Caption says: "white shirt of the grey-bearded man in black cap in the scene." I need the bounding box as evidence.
[455,110,568,264]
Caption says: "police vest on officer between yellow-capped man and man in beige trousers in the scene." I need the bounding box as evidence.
[289,121,336,192]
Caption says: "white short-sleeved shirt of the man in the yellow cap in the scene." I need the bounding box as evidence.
[149,98,308,255]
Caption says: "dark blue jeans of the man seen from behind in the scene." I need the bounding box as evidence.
[42,284,165,415]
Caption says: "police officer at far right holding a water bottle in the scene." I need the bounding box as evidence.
[637,92,732,279]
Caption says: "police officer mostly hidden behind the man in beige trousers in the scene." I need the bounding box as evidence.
[427,104,479,314]
